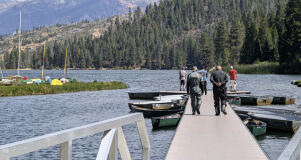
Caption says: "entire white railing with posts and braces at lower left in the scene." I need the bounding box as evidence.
[0,113,150,160]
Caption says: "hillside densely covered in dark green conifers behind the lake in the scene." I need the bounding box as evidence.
[5,0,301,73]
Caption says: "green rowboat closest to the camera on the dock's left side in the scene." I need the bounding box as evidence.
[152,113,181,129]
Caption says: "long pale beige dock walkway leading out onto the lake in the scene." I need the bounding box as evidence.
[166,91,268,160]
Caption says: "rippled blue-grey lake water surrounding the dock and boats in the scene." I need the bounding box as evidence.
[0,70,301,160]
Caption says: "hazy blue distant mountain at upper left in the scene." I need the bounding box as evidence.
[0,0,158,35]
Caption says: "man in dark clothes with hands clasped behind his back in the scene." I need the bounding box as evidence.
[210,66,228,116]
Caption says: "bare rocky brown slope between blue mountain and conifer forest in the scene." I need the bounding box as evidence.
[0,16,127,55]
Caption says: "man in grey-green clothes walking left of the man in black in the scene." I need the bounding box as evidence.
[186,66,203,115]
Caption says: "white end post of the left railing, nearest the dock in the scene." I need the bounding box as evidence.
[136,119,150,160]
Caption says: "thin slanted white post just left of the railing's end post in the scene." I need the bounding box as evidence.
[118,127,132,160]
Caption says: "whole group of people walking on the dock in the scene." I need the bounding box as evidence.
[179,66,237,116]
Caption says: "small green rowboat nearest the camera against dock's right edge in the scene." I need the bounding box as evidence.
[244,119,267,136]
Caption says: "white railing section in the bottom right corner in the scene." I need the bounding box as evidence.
[277,127,301,160]
